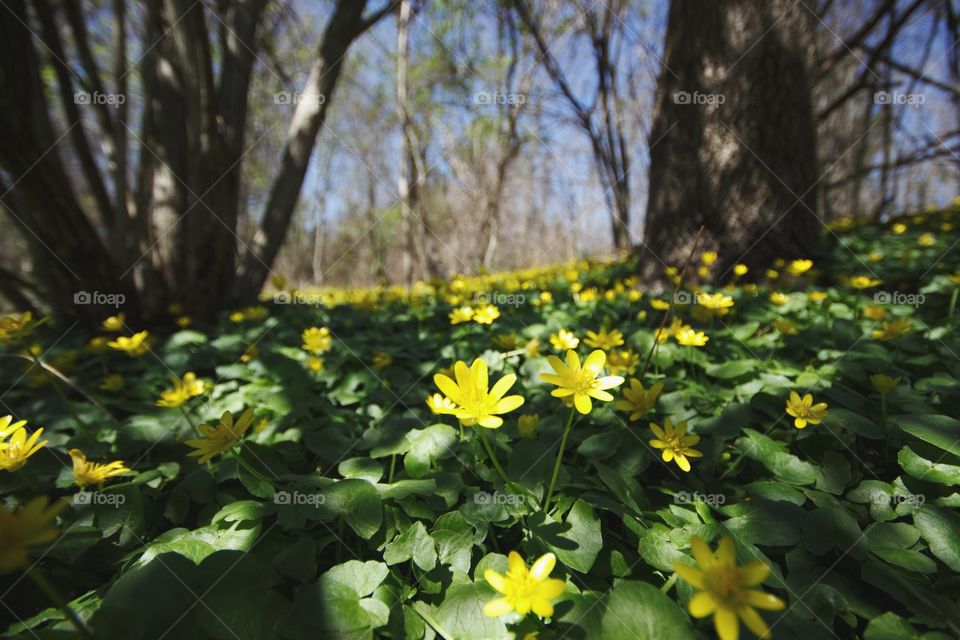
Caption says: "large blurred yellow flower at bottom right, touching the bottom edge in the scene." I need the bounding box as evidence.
[673,536,786,640]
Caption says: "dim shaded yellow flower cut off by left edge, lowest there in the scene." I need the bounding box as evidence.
[0,496,67,574]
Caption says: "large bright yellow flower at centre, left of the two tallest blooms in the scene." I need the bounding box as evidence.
[433,358,524,429]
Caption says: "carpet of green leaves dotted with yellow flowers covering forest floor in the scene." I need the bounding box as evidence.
[0,204,960,640]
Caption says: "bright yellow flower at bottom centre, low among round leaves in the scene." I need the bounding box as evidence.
[483,551,566,618]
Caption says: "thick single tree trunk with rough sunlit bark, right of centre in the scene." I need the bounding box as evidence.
[639,0,820,277]
